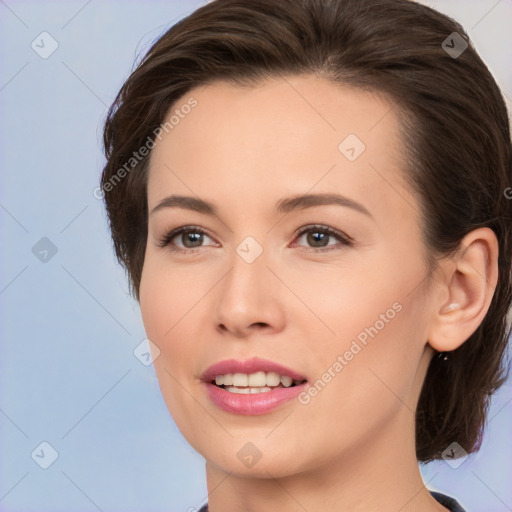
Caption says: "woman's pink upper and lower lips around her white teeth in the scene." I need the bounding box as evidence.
[201,357,308,415]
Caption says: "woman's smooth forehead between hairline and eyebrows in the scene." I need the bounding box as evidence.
[148,75,416,220]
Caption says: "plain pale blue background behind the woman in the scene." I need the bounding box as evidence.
[0,0,512,512]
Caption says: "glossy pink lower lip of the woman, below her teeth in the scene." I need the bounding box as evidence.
[205,382,307,416]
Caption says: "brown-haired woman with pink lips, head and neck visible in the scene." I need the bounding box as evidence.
[102,0,512,512]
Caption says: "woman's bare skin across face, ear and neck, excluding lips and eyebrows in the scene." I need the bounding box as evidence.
[140,75,498,512]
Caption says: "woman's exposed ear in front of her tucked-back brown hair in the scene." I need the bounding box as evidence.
[428,228,499,352]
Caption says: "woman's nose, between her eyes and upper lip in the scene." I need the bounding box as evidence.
[216,246,285,338]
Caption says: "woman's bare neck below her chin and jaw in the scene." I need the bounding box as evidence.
[206,407,447,512]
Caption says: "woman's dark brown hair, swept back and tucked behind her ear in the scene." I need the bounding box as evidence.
[102,0,512,462]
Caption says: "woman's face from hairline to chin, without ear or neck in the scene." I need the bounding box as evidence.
[140,75,440,476]
